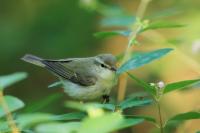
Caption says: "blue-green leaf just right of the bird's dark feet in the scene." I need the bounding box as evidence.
[119,98,152,110]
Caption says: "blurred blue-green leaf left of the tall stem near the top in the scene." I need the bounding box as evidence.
[101,16,136,27]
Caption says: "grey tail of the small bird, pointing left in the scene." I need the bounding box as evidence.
[21,54,45,67]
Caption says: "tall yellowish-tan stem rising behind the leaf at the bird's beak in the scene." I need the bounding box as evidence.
[118,0,151,102]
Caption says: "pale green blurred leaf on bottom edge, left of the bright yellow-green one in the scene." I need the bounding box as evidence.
[35,122,80,133]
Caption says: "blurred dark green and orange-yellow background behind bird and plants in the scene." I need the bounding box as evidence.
[0,0,200,133]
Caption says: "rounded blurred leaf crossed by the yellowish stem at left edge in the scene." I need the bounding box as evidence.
[0,96,24,117]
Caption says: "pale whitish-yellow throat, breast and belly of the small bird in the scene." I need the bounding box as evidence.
[63,69,117,100]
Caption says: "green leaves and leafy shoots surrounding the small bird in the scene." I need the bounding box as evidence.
[0,0,200,133]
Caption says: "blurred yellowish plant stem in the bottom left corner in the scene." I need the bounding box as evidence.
[0,91,20,133]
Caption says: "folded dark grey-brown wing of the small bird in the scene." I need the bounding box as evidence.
[42,59,97,86]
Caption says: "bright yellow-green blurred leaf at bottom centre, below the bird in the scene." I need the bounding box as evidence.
[79,113,143,133]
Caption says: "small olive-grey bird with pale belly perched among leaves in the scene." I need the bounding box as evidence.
[22,54,118,103]
